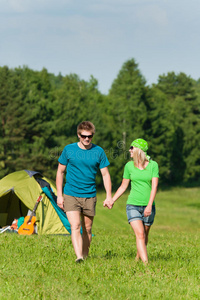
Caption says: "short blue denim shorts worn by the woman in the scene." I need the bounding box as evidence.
[126,204,156,226]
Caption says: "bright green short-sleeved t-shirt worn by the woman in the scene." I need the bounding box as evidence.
[123,160,159,206]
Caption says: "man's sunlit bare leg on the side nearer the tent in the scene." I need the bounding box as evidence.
[66,211,83,259]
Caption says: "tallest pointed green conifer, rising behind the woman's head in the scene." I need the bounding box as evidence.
[107,59,147,185]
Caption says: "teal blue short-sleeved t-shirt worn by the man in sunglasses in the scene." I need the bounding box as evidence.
[58,143,110,198]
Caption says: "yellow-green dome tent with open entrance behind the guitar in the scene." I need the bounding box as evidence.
[0,170,71,234]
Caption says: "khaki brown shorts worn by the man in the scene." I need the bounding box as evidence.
[64,194,97,217]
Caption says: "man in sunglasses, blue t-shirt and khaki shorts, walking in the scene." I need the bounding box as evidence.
[56,121,112,262]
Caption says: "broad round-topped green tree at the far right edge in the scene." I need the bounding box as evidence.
[150,72,199,184]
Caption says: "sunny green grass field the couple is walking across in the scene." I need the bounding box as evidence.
[0,188,200,300]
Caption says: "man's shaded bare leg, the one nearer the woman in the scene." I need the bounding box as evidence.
[81,214,94,258]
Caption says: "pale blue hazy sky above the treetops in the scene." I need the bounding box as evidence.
[0,0,200,94]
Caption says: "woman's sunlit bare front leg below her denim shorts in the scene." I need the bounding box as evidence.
[130,220,148,263]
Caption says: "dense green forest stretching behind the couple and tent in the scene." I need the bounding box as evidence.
[0,59,200,188]
